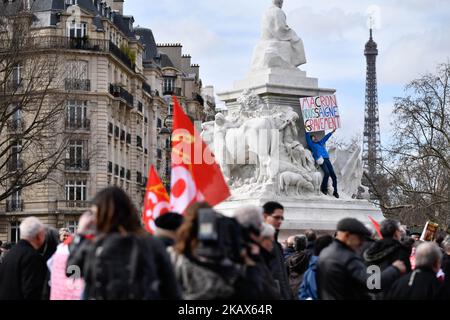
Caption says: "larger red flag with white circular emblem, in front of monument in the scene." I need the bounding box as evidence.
[170,96,230,213]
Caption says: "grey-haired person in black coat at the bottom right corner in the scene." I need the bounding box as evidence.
[386,242,444,300]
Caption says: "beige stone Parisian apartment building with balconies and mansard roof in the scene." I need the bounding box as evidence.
[0,0,214,243]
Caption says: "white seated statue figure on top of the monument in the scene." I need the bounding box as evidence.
[252,0,306,70]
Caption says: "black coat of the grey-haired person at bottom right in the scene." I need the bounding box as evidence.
[385,267,444,300]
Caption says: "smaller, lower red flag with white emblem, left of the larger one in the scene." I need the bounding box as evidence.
[142,166,170,234]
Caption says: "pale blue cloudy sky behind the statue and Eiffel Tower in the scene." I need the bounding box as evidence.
[124,0,450,143]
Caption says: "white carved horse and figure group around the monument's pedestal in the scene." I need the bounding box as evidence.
[201,90,362,198]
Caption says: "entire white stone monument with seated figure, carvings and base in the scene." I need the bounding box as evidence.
[210,0,384,236]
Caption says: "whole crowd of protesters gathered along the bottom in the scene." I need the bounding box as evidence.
[0,187,450,300]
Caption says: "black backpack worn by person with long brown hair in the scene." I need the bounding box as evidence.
[86,234,159,300]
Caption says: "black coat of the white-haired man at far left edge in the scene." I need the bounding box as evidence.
[0,240,46,300]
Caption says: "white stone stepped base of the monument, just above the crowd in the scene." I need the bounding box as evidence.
[216,195,385,239]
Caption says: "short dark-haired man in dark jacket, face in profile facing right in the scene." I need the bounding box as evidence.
[263,202,293,300]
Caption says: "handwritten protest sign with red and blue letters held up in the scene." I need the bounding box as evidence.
[300,95,341,132]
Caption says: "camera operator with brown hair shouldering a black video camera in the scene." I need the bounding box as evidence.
[168,202,241,300]
